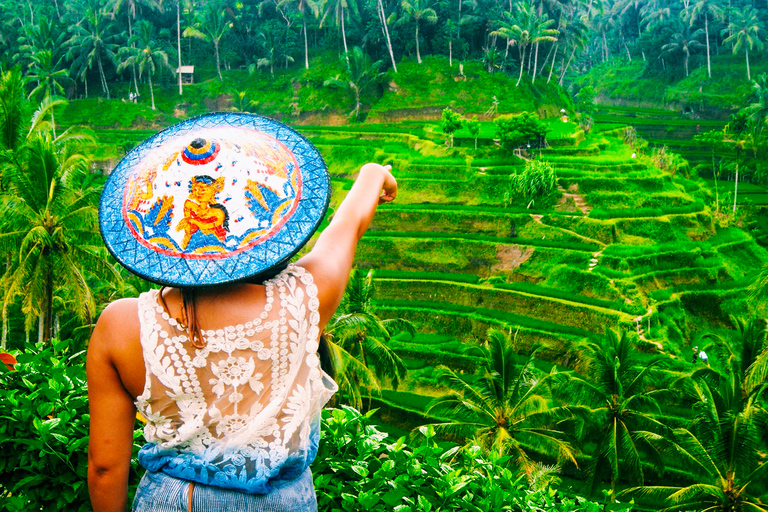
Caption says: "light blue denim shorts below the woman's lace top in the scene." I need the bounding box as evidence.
[132,468,317,512]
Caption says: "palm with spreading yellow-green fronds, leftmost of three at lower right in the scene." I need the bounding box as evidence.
[428,329,576,472]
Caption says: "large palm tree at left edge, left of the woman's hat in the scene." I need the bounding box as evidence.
[0,102,119,341]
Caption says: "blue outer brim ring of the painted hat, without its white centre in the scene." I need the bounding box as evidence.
[99,112,330,287]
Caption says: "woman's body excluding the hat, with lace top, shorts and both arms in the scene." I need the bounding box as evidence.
[87,114,397,512]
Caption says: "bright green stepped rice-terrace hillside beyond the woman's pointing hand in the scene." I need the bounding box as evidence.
[290,119,768,422]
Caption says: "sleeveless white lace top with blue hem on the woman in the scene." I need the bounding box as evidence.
[136,265,338,494]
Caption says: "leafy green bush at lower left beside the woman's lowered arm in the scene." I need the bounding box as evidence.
[0,340,141,512]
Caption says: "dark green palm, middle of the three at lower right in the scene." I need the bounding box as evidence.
[566,329,669,502]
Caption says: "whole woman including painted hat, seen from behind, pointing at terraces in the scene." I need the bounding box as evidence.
[87,113,397,512]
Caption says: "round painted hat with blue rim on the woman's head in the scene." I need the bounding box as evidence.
[99,113,330,287]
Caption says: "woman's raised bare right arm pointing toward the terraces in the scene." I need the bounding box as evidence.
[298,163,397,328]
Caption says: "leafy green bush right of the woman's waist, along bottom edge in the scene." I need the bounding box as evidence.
[312,407,632,512]
